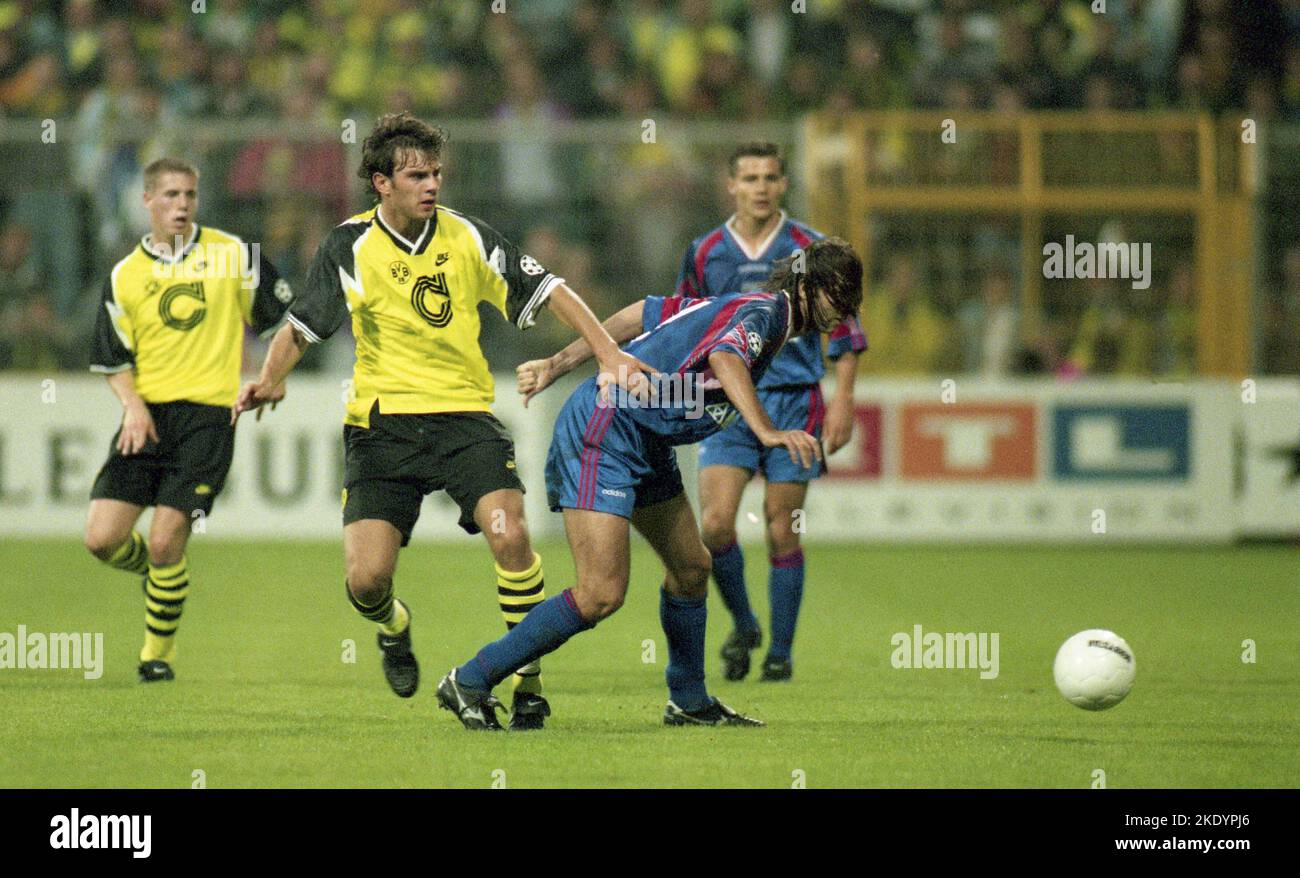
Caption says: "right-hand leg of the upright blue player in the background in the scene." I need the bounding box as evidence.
[762,481,809,680]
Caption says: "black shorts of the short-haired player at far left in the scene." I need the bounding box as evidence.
[90,402,235,515]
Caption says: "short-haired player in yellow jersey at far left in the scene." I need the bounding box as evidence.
[86,159,293,683]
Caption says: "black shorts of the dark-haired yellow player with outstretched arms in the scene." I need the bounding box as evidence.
[343,402,524,545]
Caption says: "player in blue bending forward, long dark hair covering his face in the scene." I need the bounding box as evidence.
[438,238,862,730]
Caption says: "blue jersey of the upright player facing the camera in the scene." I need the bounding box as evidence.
[677,211,867,389]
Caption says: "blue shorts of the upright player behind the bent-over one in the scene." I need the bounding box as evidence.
[699,384,826,481]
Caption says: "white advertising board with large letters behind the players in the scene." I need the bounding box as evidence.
[0,375,1300,542]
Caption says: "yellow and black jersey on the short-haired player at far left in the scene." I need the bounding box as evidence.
[90,225,294,406]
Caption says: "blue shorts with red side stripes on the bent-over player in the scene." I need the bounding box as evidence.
[546,379,683,518]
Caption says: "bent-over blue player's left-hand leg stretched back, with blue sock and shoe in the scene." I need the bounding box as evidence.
[438,509,631,730]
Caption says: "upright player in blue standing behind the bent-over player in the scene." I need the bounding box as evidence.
[677,143,867,680]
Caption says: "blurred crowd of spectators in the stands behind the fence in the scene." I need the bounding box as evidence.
[0,0,1300,375]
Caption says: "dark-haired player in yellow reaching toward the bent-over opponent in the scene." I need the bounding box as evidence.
[233,113,649,730]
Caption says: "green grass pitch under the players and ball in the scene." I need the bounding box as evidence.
[0,537,1300,788]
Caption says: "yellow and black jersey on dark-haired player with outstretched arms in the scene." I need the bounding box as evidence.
[289,207,564,427]
